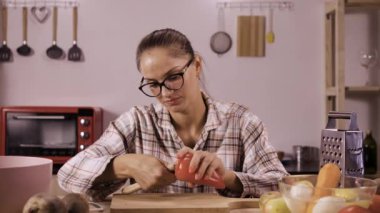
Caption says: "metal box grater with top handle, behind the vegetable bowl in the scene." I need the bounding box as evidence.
[319,112,364,177]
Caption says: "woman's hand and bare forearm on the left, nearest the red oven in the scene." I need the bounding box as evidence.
[113,154,176,190]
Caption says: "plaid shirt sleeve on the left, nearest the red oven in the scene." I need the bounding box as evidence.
[57,110,137,200]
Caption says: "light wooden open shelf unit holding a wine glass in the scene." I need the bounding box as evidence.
[324,0,380,123]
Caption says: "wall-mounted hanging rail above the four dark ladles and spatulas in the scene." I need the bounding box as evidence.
[1,0,79,8]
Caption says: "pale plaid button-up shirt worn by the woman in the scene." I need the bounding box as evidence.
[58,94,287,199]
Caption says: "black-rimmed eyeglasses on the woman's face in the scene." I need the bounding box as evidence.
[139,58,194,97]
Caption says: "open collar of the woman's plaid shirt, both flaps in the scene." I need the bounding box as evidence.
[156,91,221,131]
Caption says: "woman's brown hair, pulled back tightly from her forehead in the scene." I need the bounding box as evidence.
[136,28,194,70]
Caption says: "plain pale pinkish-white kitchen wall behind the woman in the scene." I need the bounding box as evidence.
[0,0,325,156]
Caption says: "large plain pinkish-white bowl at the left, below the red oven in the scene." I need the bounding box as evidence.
[0,156,53,213]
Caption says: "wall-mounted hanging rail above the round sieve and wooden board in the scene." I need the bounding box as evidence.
[216,1,294,11]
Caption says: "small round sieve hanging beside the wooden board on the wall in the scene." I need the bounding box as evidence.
[210,7,232,55]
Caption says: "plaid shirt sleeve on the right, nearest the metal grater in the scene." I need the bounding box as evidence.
[220,113,288,197]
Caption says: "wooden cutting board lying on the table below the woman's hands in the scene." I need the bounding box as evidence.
[111,193,259,213]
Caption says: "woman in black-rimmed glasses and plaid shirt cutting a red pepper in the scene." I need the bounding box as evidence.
[58,29,287,198]
